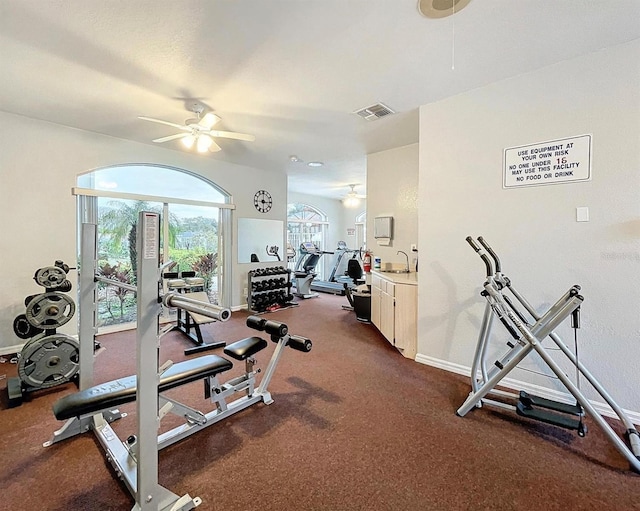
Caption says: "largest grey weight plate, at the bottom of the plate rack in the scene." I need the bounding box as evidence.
[18,334,80,389]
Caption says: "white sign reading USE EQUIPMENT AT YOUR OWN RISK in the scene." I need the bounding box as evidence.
[502,135,591,188]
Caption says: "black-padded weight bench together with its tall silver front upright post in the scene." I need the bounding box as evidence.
[44,212,311,511]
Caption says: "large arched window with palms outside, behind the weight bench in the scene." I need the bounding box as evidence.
[76,164,233,332]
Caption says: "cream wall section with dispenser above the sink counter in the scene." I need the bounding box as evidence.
[367,144,420,269]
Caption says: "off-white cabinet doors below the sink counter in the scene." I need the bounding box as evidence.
[371,273,418,358]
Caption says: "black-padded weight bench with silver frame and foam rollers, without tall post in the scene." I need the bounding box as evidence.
[44,310,312,511]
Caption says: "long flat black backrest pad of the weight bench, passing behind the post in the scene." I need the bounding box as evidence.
[53,355,233,420]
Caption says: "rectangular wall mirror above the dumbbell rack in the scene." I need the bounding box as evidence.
[238,218,286,263]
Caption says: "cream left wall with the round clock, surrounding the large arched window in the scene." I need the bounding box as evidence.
[0,112,287,350]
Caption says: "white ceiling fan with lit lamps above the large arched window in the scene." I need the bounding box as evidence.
[138,104,256,153]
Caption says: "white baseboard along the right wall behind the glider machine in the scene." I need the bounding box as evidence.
[415,353,640,424]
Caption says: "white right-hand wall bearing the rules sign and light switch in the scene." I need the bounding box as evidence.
[417,40,640,411]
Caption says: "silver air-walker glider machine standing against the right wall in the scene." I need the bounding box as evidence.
[456,236,640,472]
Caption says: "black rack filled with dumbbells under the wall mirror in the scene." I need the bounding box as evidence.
[247,266,298,313]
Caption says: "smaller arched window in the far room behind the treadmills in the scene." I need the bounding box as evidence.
[287,203,329,280]
